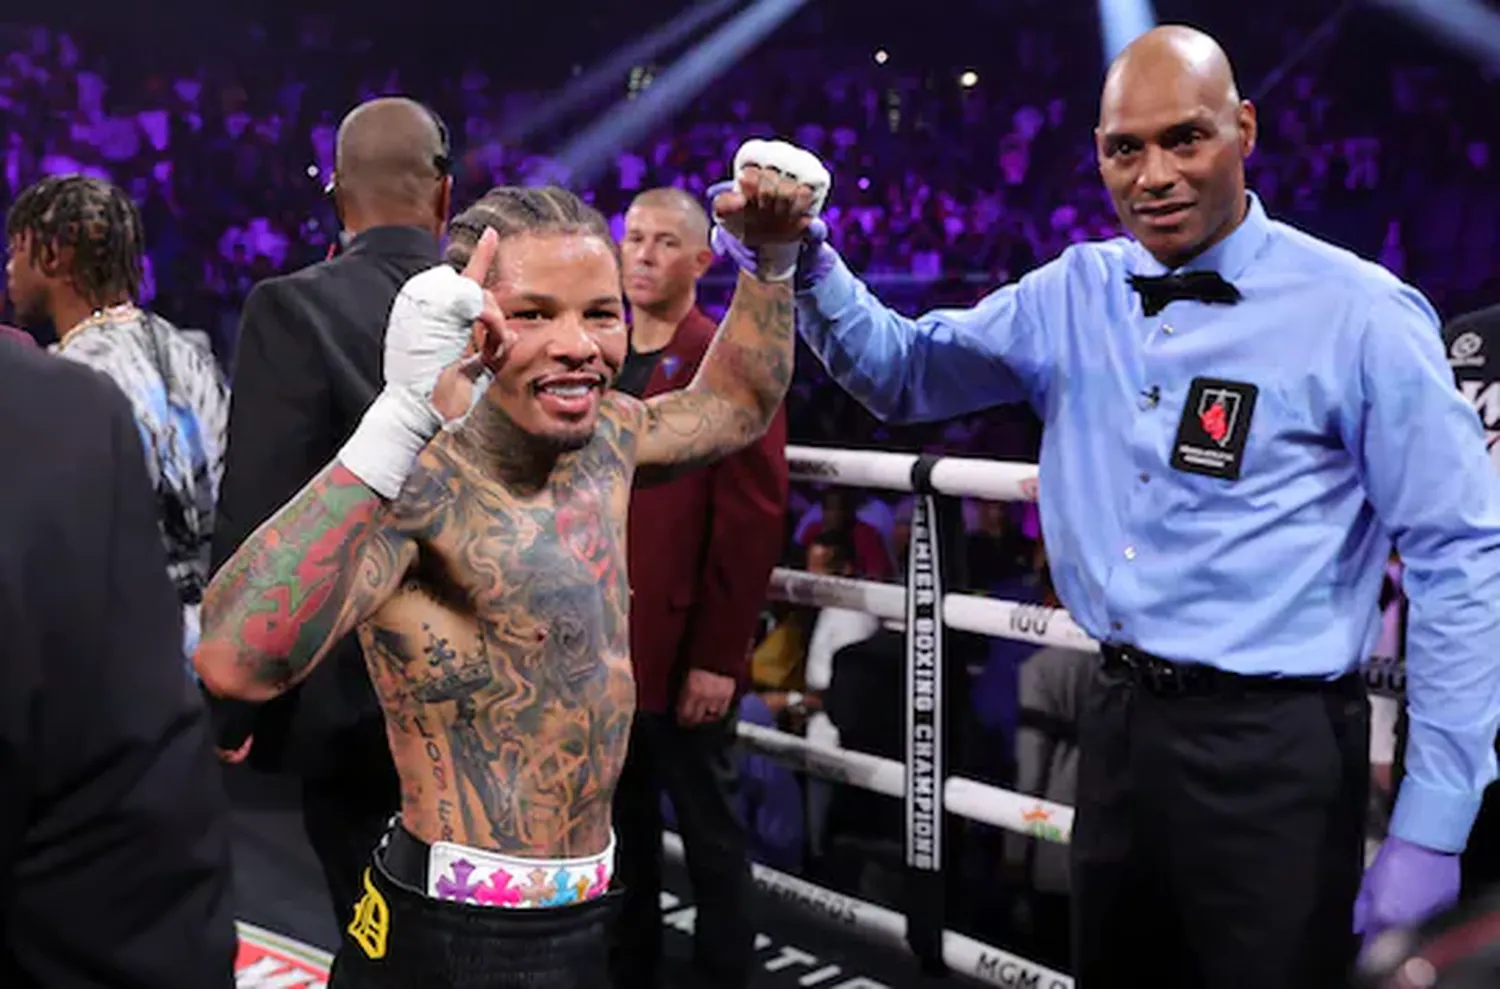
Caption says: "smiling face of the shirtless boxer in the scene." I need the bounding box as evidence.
[486,233,626,450]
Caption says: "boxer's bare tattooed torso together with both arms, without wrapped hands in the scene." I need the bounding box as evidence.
[198,265,795,857]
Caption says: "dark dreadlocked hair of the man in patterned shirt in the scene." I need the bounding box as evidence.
[5,176,146,306]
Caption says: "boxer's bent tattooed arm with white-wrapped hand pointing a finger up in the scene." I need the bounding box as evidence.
[194,233,507,701]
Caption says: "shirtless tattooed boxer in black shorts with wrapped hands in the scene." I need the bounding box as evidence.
[197,143,827,989]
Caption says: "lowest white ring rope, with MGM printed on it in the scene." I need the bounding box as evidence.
[662,831,1073,989]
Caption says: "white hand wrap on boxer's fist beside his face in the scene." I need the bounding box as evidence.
[339,264,485,500]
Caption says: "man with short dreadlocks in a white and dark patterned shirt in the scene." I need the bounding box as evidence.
[6,176,230,656]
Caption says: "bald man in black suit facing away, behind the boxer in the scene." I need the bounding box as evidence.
[213,98,453,926]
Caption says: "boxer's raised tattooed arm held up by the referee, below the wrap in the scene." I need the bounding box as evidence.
[636,273,797,480]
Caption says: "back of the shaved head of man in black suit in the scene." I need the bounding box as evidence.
[333,96,452,233]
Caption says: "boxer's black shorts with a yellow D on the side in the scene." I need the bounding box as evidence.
[329,825,618,989]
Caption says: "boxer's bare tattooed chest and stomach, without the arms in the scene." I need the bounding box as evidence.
[362,435,635,855]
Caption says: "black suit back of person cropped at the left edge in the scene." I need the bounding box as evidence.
[0,339,236,989]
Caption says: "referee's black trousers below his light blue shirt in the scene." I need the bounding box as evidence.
[1073,663,1370,989]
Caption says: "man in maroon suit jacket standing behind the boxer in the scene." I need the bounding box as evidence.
[611,189,788,989]
